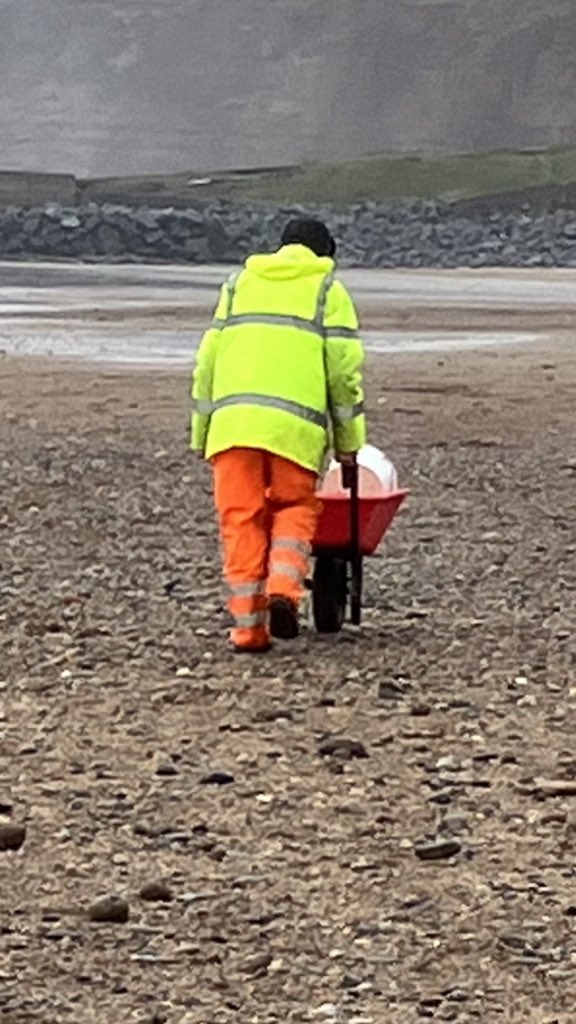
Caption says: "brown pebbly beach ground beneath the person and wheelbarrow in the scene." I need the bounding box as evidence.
[0,336,576,1024]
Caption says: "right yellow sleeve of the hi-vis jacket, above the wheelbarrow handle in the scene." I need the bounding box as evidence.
[324,281,366,453]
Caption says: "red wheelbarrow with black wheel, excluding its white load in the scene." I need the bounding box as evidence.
[310,465,408,633]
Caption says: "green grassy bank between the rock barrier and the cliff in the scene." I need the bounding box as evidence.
[80,146,576,205]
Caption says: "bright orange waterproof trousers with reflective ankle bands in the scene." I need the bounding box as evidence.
[212,447,320,648]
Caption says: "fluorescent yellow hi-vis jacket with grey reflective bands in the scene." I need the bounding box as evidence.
[192,245,366,472]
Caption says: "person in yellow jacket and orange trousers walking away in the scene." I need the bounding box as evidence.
[191,219,366,652]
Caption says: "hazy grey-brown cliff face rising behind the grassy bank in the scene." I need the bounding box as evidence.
[0,0,576,176]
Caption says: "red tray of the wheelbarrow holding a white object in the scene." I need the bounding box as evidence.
[313,490,408,555]
